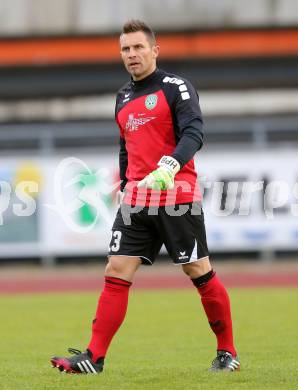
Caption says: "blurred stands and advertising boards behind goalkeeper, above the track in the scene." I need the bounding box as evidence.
[0,0,298,264]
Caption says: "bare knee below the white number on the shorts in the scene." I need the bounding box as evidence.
[105,256,141,282]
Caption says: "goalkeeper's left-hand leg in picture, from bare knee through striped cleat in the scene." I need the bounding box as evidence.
[51,256,141,374]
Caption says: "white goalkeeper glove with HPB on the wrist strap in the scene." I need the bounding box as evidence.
[138,156,180,190]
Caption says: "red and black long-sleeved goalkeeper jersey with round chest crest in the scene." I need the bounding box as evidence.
[115,69,203,206]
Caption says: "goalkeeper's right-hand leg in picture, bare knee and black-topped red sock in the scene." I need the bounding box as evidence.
[182,257,239,369]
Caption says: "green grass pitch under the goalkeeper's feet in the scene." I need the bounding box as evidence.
[0,289,298,390]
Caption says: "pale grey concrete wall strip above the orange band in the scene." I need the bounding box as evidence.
[0,0,298,35]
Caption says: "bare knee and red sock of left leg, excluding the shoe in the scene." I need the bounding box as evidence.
[88,256,141,362]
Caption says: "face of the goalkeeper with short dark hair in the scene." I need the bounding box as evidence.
[120,31,159,81]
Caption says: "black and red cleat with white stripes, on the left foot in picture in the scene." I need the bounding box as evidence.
[51,348,104,374]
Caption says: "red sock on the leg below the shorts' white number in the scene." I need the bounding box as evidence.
[88,277,131,362]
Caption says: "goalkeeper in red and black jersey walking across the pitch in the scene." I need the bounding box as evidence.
[51,20,240,373]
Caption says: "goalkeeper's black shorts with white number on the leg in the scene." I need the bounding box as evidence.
[109,203,209,265]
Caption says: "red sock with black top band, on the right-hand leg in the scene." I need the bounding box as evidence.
[193,271,237,356]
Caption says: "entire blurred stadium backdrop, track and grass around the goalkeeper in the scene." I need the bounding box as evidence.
[0,0,298,390]
